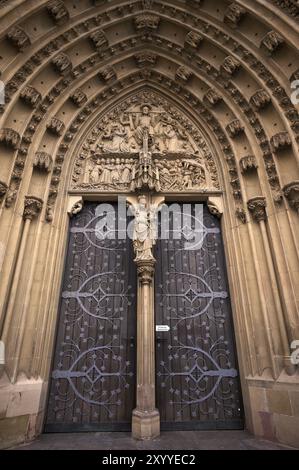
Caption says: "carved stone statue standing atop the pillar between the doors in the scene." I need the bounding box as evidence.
[133,196,157,261]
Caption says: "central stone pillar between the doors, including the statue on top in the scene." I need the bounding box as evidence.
[128,194,164,439]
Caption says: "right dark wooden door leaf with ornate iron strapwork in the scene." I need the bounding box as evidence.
[155,205,243,429]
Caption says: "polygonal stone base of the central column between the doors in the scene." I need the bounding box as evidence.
[132,409,160,440]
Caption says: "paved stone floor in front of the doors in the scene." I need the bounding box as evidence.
[17,431,298,450]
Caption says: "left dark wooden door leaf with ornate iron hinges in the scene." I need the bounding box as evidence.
[45,203,136,432]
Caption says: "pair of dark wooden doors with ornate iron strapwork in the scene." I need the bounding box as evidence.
[45,203,242,432]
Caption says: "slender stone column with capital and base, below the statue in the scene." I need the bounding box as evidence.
[132,260,160,439]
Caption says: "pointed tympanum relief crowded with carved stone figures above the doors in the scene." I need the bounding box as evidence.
[72,92,219,192]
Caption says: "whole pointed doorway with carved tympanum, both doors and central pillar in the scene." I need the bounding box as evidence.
[46,92,242,438]
